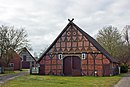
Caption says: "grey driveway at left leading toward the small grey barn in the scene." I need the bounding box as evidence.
[0,72,28,84]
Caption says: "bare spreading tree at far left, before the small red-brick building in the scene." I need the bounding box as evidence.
[0,25,29,65]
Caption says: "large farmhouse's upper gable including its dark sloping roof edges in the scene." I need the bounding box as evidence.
[38,22,116,62]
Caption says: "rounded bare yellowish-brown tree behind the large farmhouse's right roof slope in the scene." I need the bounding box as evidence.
[96,26,123,57]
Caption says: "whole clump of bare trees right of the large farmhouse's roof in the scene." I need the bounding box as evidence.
[96,26,130,66]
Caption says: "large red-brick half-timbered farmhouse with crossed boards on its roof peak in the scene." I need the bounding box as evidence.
[38,20,117,76]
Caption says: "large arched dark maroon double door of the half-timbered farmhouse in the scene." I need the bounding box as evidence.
[63,56,81,76]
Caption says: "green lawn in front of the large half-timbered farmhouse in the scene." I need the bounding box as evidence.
[2,75,121,87]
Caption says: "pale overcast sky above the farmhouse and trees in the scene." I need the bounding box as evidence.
[0,0,130,54]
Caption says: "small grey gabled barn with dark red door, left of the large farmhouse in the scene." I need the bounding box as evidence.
[19,47,36,69]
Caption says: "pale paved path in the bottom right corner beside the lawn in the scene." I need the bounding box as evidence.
[114,74,130,87]
